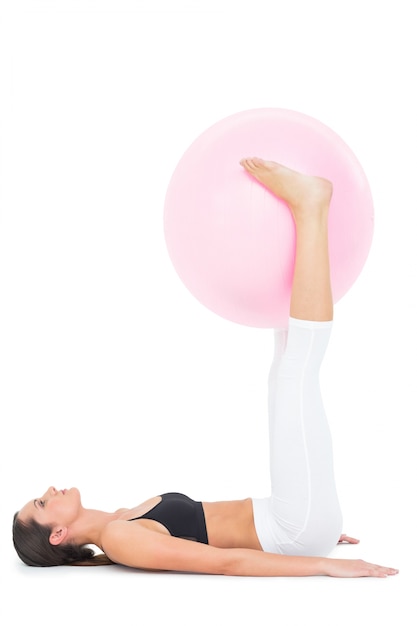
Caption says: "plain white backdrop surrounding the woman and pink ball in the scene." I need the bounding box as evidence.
[0,0,417,626]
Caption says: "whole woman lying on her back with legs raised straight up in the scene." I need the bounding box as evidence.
[13,158,398,577]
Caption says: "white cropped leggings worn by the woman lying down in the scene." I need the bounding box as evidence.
[253,318,342,556]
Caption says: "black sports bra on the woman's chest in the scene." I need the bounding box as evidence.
[129,493,208,543]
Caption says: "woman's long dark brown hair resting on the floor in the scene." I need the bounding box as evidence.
[13,513,113,567]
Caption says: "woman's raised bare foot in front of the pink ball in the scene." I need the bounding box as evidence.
[240,157,333,217]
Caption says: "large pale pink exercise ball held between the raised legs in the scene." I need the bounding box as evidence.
[164,108,374,328]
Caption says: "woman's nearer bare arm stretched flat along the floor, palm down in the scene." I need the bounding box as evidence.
[102,521,397,578]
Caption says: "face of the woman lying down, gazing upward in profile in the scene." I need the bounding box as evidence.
[19,487,81,527]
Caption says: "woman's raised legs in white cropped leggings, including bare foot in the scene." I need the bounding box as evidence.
[241,158,342,555]
